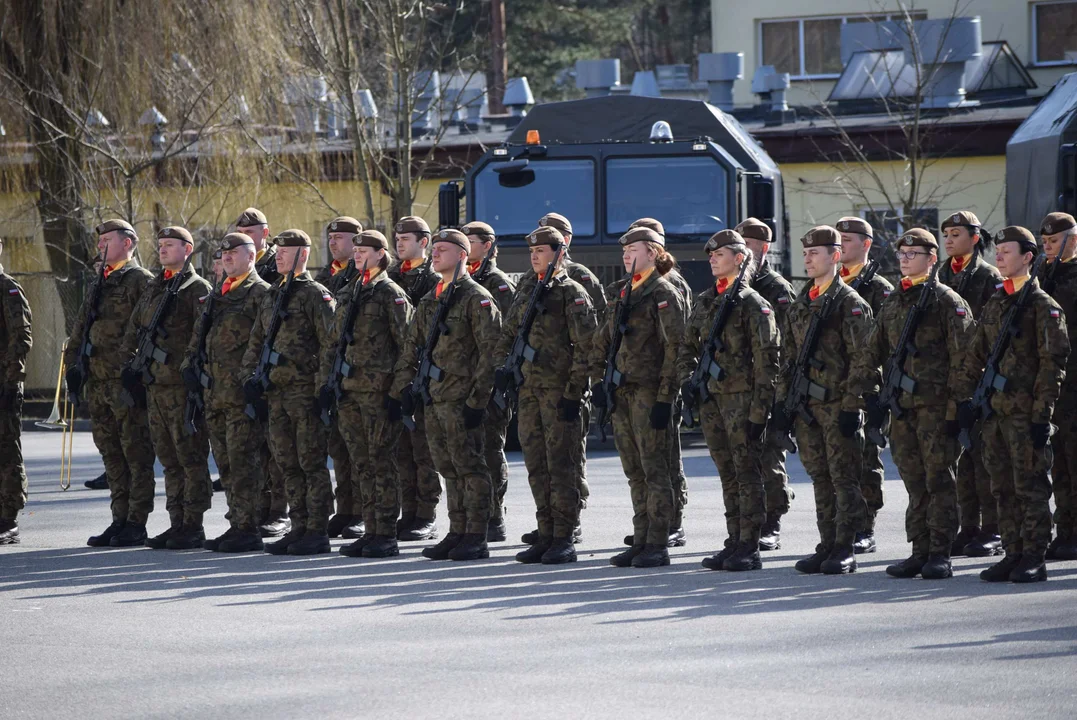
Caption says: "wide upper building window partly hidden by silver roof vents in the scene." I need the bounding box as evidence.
[759,11,930,80]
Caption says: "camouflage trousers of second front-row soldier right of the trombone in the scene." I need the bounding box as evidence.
[145,384,213,527]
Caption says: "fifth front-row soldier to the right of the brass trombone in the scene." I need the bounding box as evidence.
[321,230,411,557]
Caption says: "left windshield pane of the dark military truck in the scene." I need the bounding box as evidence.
[475,159,596,237]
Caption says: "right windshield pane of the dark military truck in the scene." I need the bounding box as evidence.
[607,155,730,240]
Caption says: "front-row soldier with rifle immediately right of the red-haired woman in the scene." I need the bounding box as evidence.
[677,230,780,570]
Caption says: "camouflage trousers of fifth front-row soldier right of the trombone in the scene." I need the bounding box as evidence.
[334,392,403,537]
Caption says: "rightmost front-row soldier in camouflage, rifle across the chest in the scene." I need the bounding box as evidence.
[959,225,1069,582]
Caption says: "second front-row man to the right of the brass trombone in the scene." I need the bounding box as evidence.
[123,226,213,550]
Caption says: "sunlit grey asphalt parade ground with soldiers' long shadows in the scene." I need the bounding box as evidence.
[0,433,1077,720]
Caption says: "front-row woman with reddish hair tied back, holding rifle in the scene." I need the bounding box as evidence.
[591,227,687,567]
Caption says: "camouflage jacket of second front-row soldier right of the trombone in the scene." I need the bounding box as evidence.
[123,268,213,385]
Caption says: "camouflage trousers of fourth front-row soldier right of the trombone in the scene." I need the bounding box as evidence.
[267,385,333,533]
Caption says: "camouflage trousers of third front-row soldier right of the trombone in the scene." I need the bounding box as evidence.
[206,396,265,533]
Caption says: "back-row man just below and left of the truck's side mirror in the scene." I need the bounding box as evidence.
[389,215,442,540]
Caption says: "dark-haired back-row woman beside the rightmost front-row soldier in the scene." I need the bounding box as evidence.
[939,210,1003,557]
